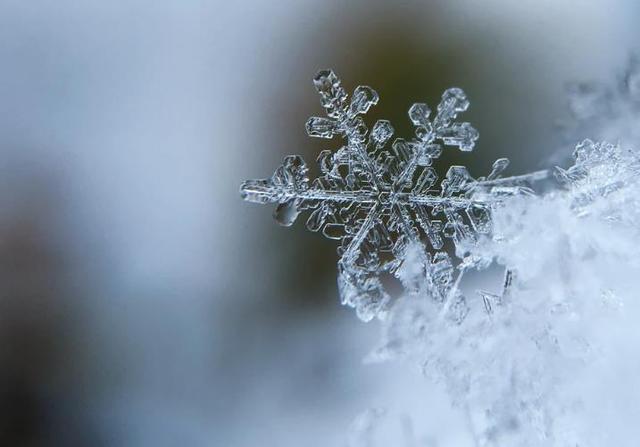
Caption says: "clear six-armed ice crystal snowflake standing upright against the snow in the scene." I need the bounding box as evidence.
[241,70,547,321]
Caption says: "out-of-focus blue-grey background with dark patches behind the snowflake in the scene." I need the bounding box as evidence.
[0,0,640,447]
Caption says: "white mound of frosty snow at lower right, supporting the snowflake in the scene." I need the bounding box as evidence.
[370,140,640,447]
